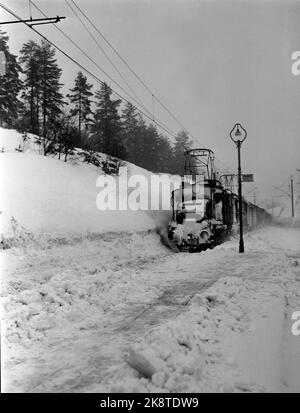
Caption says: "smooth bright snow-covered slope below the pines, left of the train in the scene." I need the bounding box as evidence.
[0,128,171,240]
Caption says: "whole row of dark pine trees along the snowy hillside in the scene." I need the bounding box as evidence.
[0,27,192,174]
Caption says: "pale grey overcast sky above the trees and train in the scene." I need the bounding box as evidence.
[0,0,300,204]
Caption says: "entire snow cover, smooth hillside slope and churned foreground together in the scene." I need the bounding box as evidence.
[0,129,300,392]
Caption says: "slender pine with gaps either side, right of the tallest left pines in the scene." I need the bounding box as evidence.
[67,72,93,142]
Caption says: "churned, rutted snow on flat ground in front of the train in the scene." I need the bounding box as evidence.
[2,227,300,393]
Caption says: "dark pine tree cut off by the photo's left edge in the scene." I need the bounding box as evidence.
[0,29,22,126]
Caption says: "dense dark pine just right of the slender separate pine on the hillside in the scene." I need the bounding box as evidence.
[92,83,126,159]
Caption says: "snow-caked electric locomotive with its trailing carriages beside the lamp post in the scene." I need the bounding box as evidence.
[168,148,272,252]
